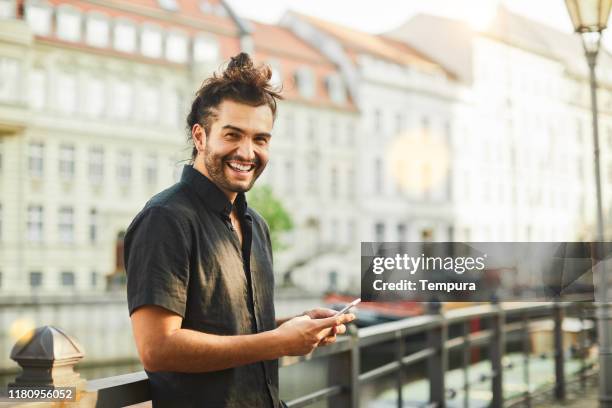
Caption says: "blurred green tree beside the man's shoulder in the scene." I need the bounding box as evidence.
[247,186,293,251]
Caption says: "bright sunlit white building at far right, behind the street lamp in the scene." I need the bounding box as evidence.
[386,7,612,241]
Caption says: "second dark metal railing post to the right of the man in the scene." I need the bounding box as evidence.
[427,302,448,408]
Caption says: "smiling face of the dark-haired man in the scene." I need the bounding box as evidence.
[198,100,274,195]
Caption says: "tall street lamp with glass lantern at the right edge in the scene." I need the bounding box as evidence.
[565,0,612,408]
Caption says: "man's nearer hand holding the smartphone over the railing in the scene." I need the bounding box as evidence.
[275,309,355,356]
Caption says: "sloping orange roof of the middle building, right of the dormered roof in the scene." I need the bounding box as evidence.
[290,11,437,68]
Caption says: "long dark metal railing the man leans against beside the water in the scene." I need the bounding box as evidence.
[4,303,594,408]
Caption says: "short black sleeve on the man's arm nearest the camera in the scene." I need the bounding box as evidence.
[124,207,189,317]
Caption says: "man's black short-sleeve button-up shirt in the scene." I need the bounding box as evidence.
[124,166,280,408]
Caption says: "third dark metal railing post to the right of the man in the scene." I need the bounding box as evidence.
[489,304,505,408]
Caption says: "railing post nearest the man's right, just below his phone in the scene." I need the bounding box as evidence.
[328,324,359,408]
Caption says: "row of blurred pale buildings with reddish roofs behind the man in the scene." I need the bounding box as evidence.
[0,0,612,293]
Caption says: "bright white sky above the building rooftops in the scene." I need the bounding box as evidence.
[228,0,612,49]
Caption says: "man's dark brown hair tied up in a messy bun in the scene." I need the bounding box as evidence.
[187,52,283,160]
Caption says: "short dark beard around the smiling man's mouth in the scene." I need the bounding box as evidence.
[204,145,266,193]
